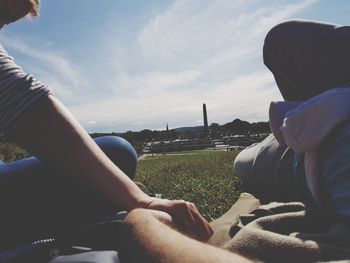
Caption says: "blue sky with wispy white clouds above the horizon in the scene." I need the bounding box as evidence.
[0,0,350,132]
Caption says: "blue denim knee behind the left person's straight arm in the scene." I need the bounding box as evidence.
[95,136,137,178]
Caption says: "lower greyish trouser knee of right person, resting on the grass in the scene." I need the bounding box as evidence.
[234,134,302,203]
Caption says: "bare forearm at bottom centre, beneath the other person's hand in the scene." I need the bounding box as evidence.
[119,209,252,263]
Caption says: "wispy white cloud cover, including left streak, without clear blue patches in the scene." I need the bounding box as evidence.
[1,0,315,131]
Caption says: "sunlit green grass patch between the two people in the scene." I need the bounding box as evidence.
[136,151,240,220]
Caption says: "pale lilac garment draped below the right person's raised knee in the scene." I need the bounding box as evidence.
[270,87,350,207]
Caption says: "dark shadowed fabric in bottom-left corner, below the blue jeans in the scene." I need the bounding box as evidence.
[0,211,127,263]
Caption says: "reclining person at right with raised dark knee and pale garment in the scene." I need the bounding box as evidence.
[234,20,350,220]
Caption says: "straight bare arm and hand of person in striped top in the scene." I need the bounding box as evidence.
[13,95,212,240]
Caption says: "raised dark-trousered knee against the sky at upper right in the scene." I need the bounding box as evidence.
[263,21,350,101]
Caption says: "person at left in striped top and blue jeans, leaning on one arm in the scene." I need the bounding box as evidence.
[0,0,212,252]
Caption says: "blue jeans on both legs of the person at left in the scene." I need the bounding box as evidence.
[0,136,137,248]
